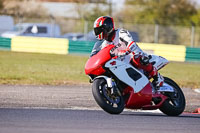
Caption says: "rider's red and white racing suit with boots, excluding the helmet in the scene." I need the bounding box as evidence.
[101,29,164,87]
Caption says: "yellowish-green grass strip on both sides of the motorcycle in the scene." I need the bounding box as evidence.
[0,51,200,88]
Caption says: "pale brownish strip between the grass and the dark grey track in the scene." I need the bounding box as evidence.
[0,84,200,112]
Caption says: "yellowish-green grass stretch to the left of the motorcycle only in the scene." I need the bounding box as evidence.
[0,51,88,85]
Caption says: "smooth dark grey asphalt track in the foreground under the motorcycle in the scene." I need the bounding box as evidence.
[0,109,200,133]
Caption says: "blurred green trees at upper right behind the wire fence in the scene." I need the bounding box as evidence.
[122,0,198,25]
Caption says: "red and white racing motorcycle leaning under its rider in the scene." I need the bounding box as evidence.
[85,45,185,116]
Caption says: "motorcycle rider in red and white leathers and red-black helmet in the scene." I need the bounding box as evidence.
[91,16,164,88]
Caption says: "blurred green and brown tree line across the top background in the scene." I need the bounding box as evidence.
[0,0,200,26]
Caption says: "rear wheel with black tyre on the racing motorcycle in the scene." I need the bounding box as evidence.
[160,77,185,116]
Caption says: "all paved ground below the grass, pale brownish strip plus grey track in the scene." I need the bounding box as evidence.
[0,85,200,133]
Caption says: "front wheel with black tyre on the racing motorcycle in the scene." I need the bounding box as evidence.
[92,78,124,114]
